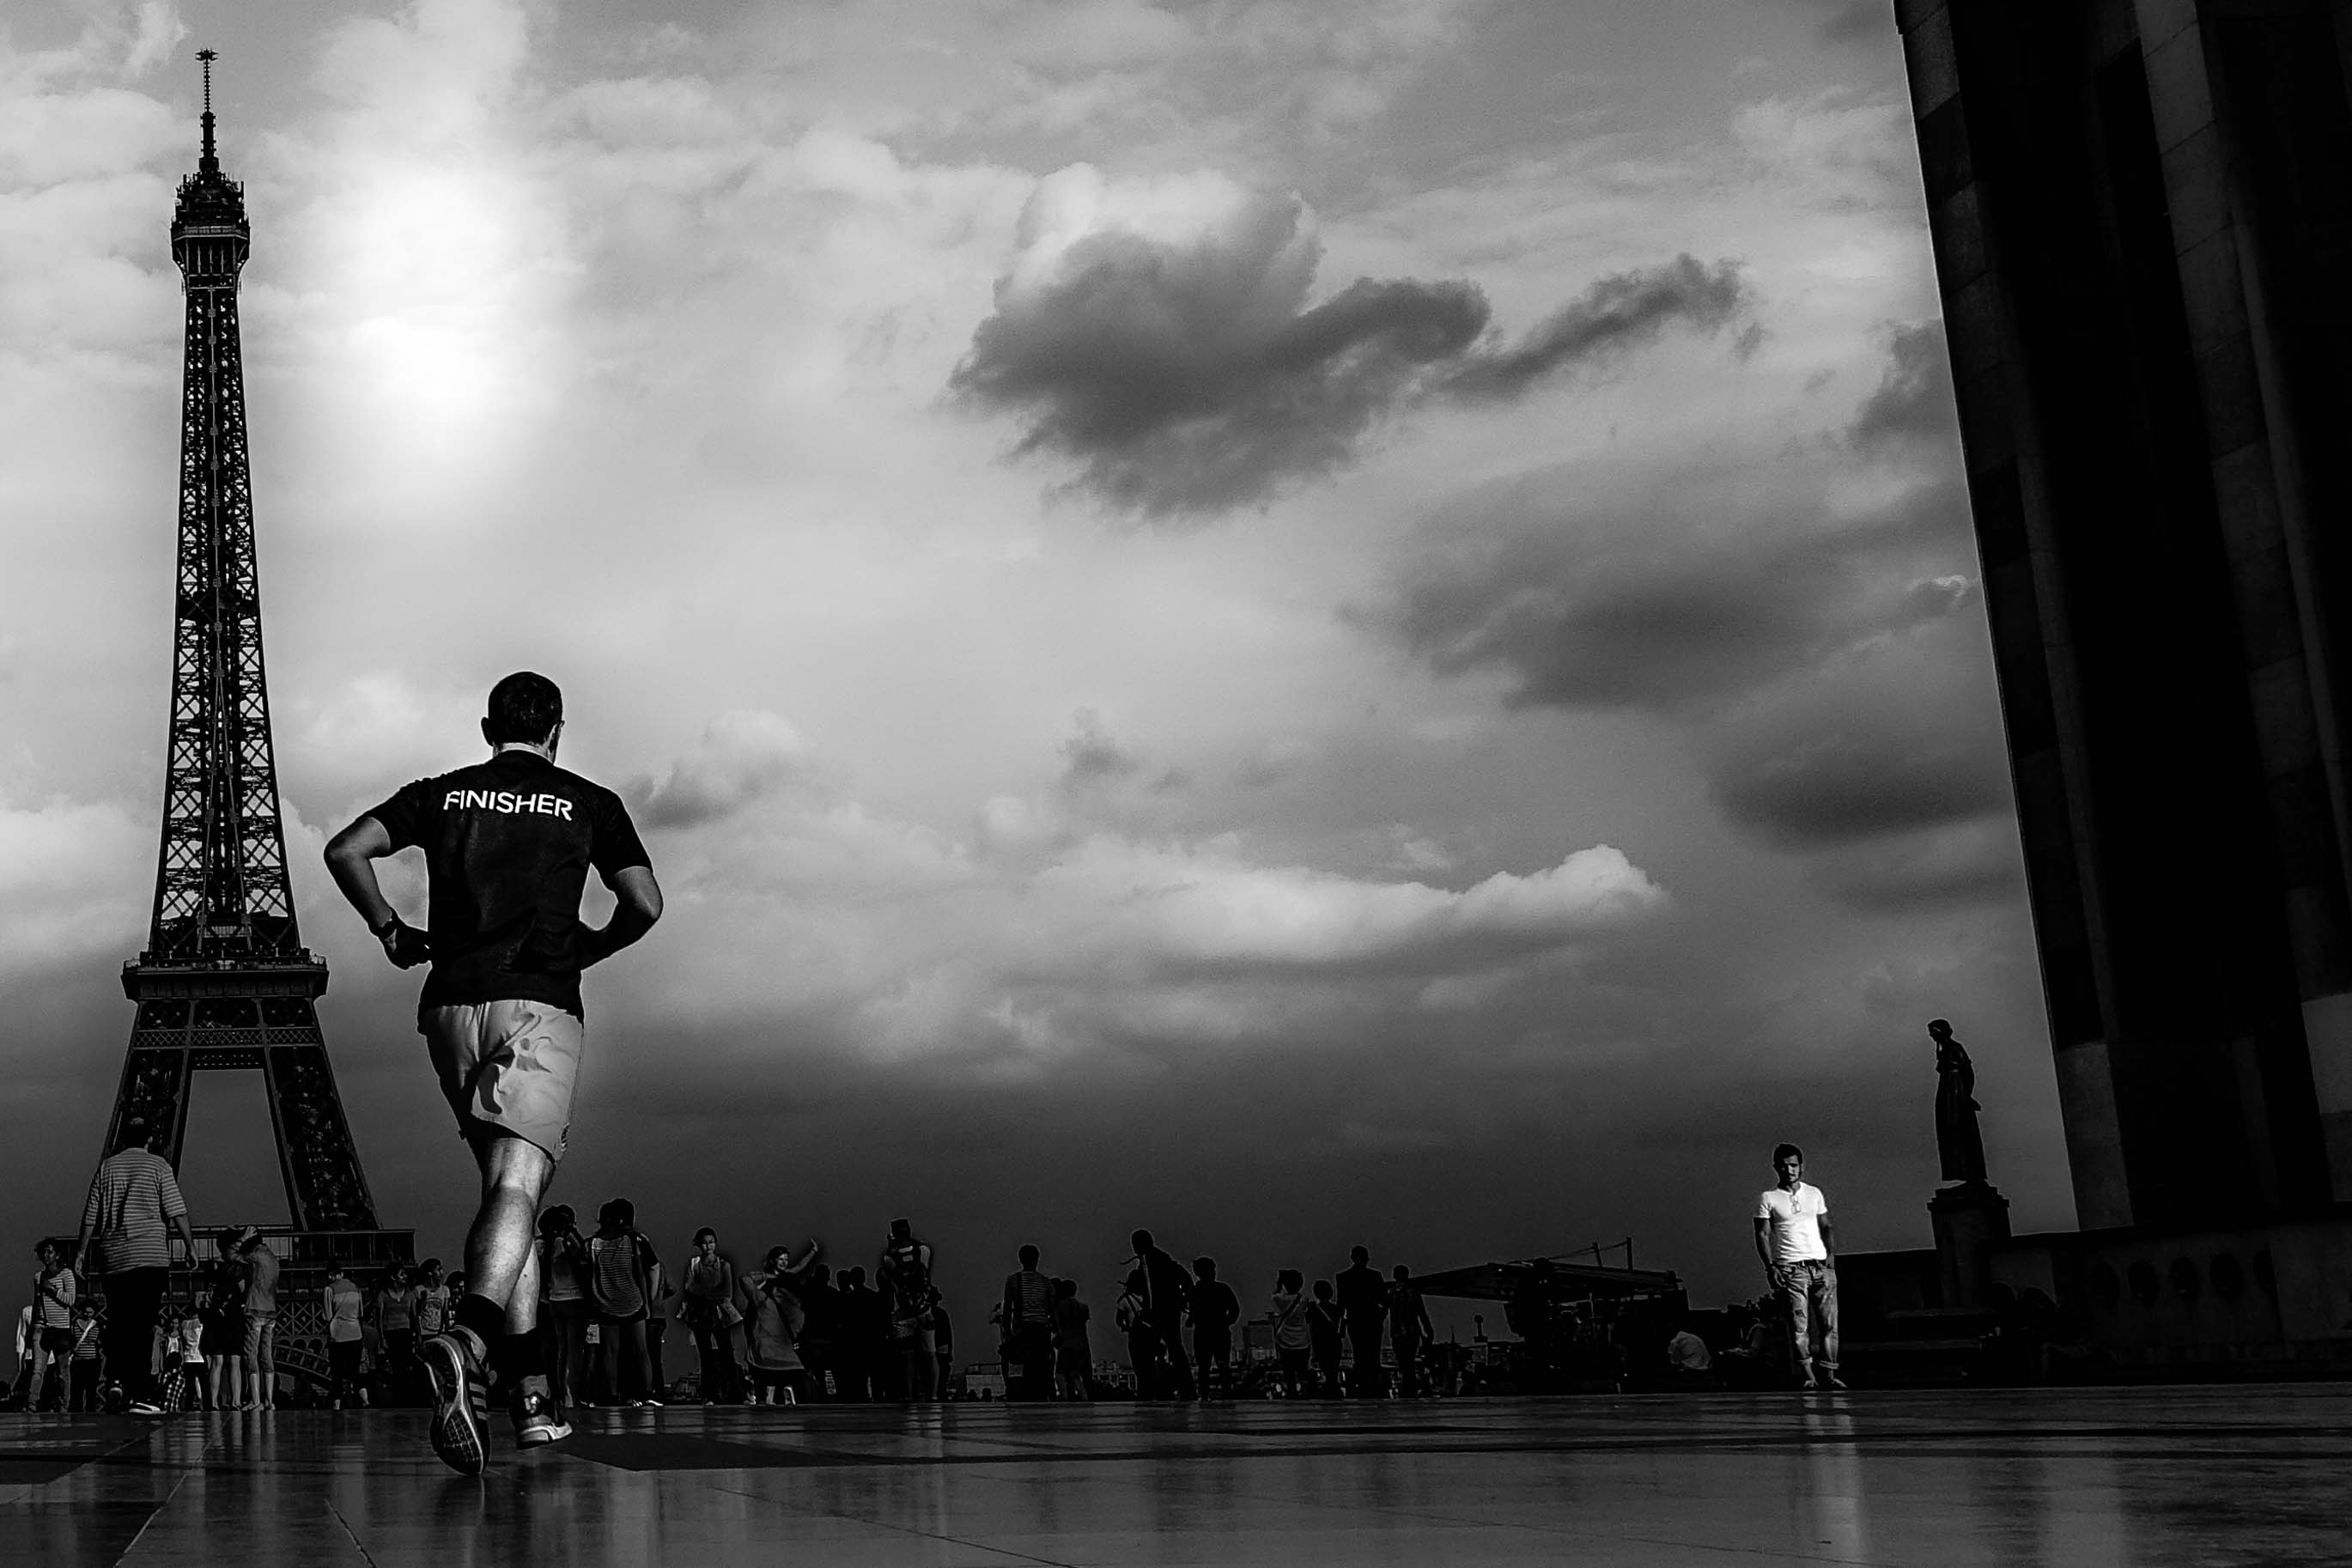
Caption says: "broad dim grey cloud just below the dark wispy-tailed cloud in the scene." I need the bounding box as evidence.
[1362,465,1966,710]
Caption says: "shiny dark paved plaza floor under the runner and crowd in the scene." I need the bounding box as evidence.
[0,1384,2352,1568]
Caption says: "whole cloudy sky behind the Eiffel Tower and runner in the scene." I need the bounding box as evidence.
[0,0,2072,1338]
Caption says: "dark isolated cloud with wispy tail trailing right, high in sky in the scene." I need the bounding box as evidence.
[948,198,1747,517]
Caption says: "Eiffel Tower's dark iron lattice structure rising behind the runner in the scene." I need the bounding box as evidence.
[106,49,376,1232]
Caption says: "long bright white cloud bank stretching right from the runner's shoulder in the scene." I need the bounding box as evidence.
[606,714,1668,1061]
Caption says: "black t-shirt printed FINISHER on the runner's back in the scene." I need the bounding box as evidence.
[369,750,652,1016]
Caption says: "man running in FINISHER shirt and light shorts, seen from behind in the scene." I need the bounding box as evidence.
[327,672,661,1476]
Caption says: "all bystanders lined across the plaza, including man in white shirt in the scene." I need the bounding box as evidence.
[9,1114,1844,1415]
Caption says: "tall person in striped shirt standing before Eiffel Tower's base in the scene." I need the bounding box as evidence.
[76,1109,195,1415]
